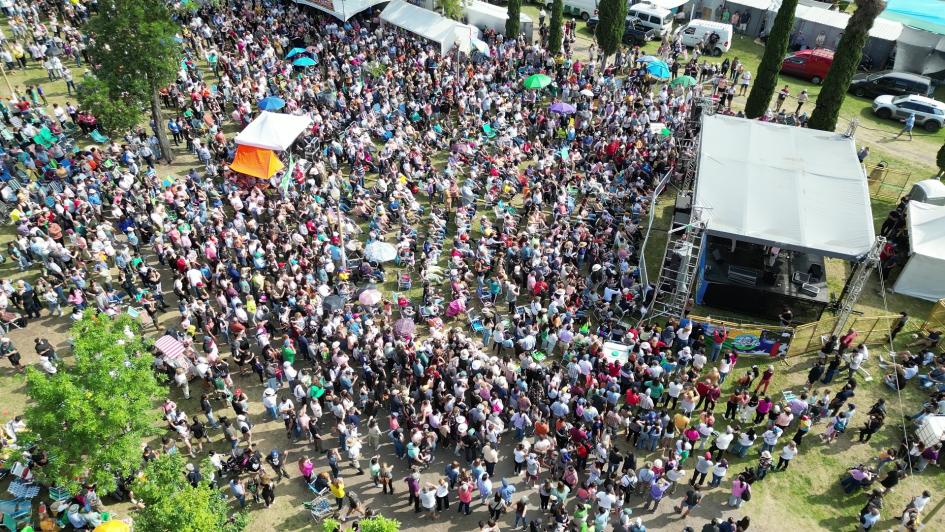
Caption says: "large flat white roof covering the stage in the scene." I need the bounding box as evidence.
[695,115,875,259]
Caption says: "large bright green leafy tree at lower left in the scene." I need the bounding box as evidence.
[22,311,163,493]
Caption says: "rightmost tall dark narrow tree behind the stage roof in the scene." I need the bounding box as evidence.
[808,0,886,131]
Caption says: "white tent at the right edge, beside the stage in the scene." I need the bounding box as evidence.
[893,201,945,301]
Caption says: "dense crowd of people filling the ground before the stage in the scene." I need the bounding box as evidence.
[0,2,945,532]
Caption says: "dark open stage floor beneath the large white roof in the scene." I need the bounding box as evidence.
[696,236,830,323]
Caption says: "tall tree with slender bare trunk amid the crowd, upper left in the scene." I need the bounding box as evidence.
[86,0,181,163]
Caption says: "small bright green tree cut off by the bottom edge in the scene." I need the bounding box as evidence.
[132,453,246,532]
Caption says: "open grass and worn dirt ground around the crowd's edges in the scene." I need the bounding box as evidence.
[0,9,945,531]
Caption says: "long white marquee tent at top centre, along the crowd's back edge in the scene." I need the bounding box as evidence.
[381,0,479,54]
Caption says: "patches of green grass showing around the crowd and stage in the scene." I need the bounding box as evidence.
[0,9,945,530]
